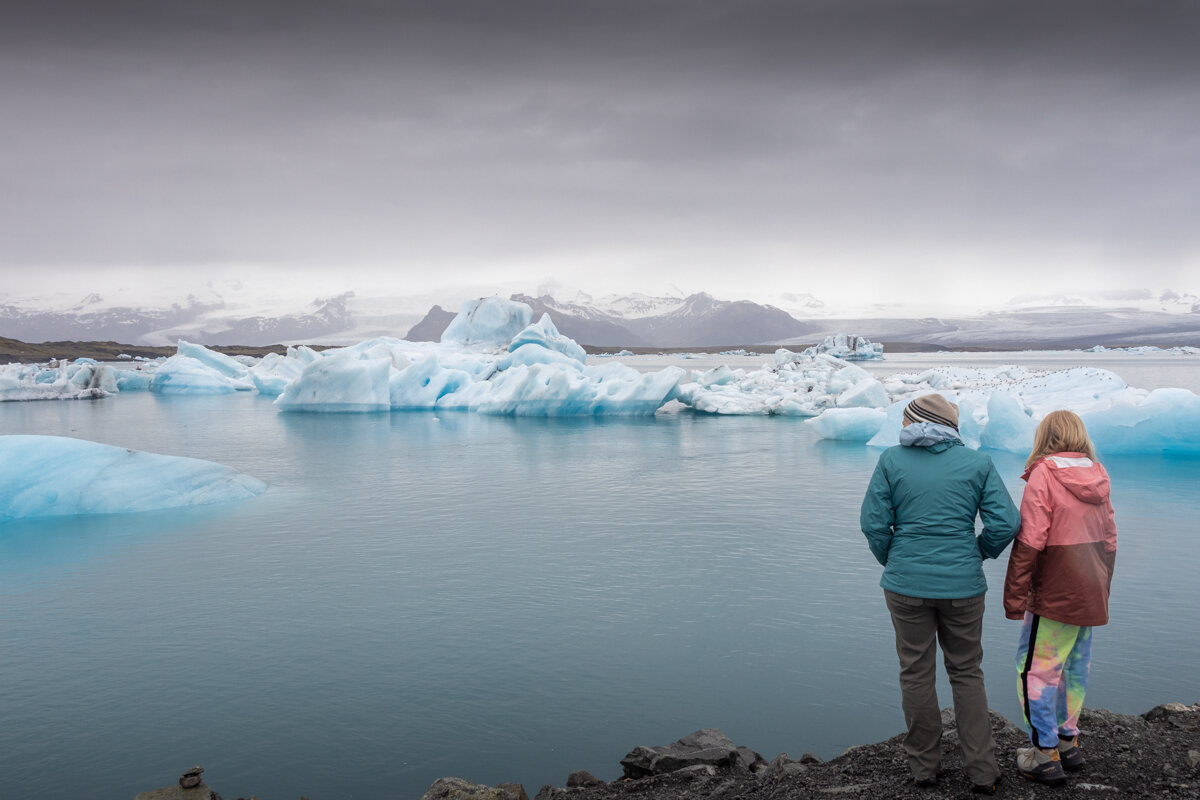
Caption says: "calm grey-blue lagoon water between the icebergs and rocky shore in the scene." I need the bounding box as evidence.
[0,357,1200,800]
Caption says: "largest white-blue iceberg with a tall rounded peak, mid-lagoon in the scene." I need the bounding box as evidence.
[253,297,685,416]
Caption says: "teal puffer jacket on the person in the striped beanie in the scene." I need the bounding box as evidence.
[859,423,1021,599]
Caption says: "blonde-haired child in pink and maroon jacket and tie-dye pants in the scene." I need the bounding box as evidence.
[1004,411,1117,786]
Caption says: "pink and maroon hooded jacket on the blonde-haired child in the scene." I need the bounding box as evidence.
[1004,452,1117,626]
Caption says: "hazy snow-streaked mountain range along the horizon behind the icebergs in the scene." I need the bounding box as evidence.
[0,291,1200,349]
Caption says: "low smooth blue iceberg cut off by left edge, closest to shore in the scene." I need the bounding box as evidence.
[0,435,266,522]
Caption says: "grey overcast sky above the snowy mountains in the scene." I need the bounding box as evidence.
[0,0,1200,306]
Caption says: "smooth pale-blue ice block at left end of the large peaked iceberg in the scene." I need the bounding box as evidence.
[275,353,392,413]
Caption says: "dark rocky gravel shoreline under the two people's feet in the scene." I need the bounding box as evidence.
[136,703,1200,800]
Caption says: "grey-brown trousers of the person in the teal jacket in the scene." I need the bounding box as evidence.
[883,589,1000,784]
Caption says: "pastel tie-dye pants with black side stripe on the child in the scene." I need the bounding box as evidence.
[1016,612,1092,747]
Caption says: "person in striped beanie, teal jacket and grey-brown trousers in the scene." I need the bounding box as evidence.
[859,395,1021,794]
